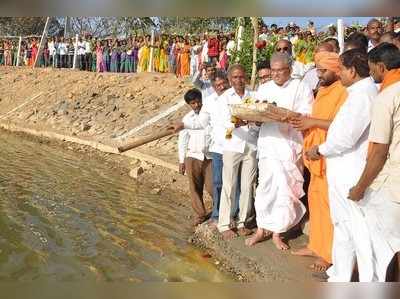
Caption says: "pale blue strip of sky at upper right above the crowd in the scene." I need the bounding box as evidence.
[263,17,372,30]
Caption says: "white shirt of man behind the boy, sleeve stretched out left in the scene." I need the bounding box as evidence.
[183,92,226,155]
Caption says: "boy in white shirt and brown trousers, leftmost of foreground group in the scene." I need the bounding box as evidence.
[178,88,213,226]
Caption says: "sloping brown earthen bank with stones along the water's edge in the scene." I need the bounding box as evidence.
[0,67,320,282]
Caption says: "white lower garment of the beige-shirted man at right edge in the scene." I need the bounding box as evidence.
[359,189,400,282]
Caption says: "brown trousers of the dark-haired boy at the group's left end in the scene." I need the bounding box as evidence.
[185,157,213,222]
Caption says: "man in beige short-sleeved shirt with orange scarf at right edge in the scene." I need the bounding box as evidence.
[349,43,400,282]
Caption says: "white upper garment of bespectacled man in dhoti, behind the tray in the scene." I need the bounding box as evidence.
[256,79,314,162]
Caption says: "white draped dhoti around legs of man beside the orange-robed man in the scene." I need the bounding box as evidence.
[255,158,306,233]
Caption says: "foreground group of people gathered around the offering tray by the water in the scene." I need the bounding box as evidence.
[170,19,400,282]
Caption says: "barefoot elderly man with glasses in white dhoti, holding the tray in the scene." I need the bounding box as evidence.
[246,53,313,250]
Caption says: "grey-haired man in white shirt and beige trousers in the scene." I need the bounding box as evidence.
[218,64,258,240]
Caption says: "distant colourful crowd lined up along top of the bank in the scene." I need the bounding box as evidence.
[0,21,400,77]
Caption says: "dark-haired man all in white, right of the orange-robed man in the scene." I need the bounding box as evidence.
[306,49,377,282]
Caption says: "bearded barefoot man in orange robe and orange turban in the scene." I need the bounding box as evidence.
[291,51,347,272]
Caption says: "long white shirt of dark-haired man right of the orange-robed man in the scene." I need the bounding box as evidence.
[319,77,377,222]
